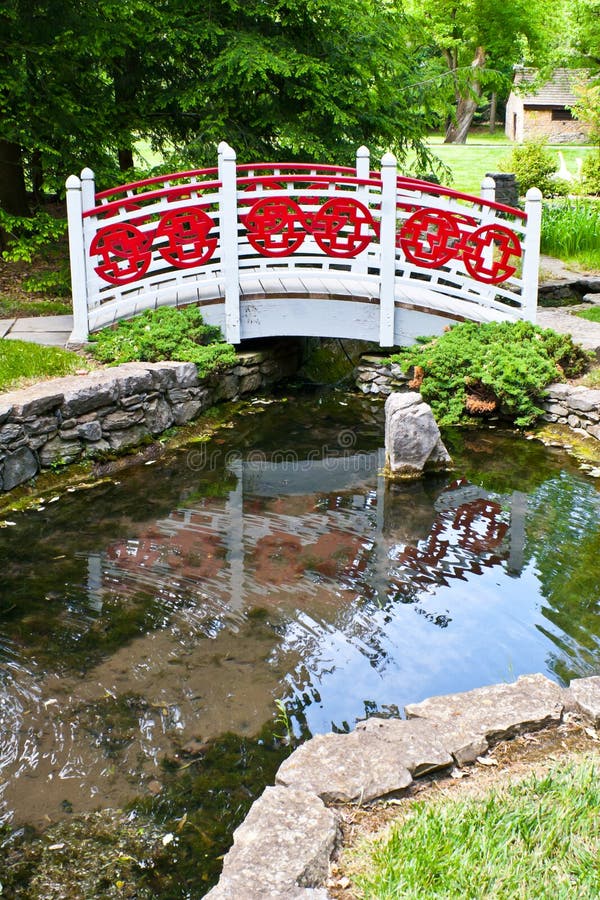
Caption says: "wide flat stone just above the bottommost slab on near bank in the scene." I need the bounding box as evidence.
[275,731,412,803]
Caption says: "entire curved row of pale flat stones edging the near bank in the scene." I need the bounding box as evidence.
[207,675,600,900]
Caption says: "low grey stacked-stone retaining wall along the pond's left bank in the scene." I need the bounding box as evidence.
[0,341,300,491]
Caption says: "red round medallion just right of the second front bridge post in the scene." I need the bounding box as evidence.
[242,197,306,257]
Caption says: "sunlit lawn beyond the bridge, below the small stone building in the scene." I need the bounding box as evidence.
[408,134,595,194]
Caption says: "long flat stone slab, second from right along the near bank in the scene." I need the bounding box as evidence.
[405,675,566,762]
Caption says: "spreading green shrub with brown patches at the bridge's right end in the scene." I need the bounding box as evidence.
[392,322,590,427]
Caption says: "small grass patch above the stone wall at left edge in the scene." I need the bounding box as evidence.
[0,338,87,391]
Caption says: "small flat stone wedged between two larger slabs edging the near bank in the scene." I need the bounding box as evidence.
[356,716,454,778]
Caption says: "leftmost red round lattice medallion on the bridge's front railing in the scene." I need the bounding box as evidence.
[90,222,152,285]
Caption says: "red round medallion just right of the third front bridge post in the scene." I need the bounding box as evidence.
[398,209,460,269]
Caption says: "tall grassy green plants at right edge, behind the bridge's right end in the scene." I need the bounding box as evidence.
[541,199,600,269]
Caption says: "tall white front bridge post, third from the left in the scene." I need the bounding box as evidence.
[379,153,396,347]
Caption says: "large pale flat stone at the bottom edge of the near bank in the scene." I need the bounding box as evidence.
[207,787,340,900]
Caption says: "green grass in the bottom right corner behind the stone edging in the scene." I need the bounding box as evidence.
[356,756,600,900]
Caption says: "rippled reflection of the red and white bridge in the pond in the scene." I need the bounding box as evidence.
[89,451,526,615]
